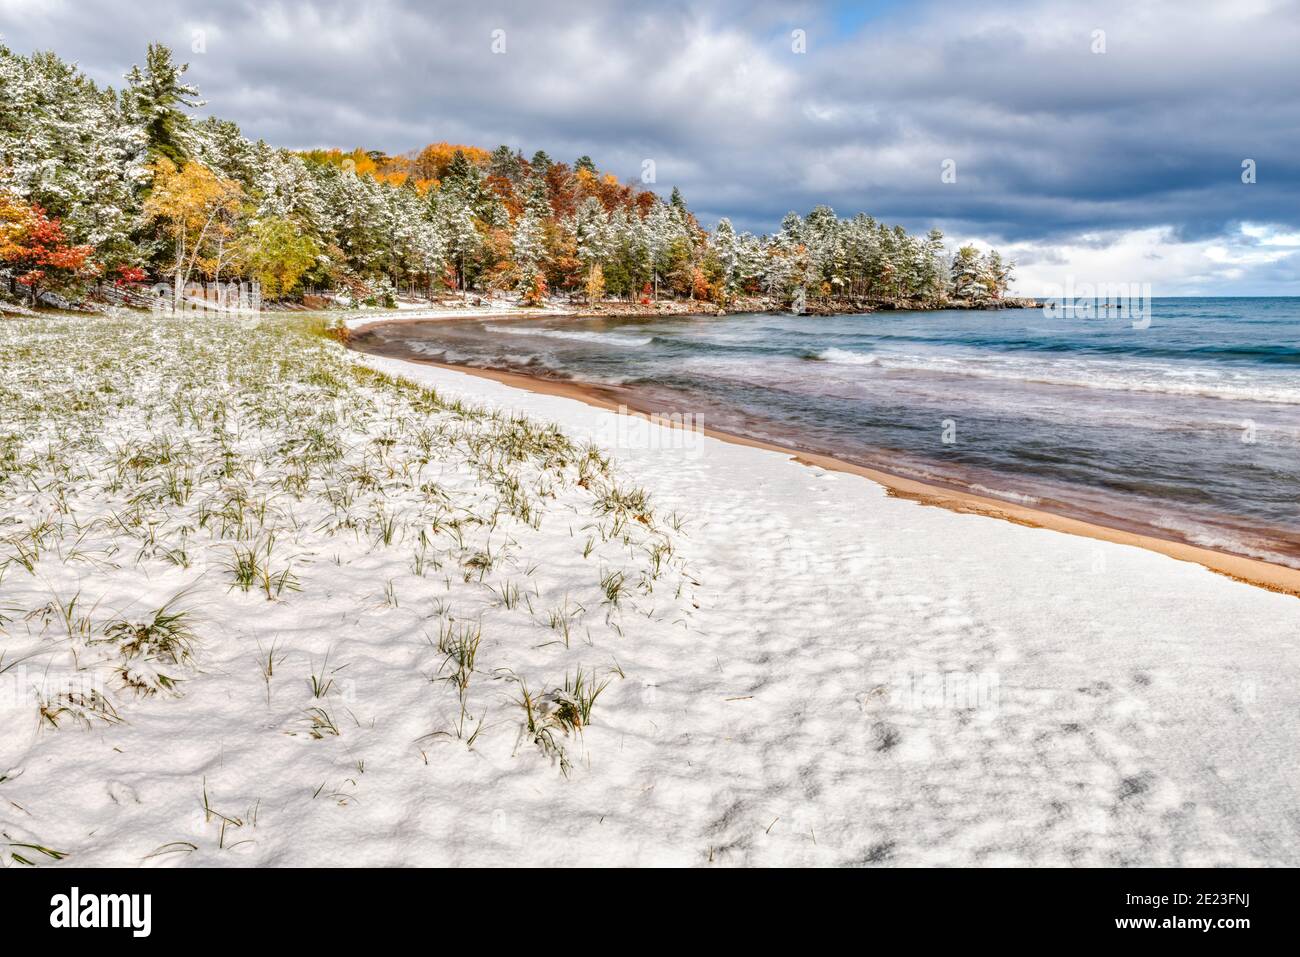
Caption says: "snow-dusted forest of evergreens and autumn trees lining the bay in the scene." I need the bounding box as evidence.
[0,44,1013,308]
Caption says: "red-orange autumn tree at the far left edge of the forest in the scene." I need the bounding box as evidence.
[0,189,99,303]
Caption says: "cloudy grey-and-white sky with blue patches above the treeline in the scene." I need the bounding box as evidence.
[0,0,1300,295]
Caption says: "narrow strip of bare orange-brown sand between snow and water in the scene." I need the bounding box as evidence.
[348,312,1300,597]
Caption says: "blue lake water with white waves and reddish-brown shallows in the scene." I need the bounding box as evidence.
[355,298,1300,567]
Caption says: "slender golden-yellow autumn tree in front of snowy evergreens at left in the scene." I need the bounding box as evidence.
[144,159,243,307]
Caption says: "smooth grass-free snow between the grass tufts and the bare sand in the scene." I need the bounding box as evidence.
[353,340,1300,866]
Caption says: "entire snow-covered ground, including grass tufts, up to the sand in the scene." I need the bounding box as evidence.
[0,312,1300,865]
